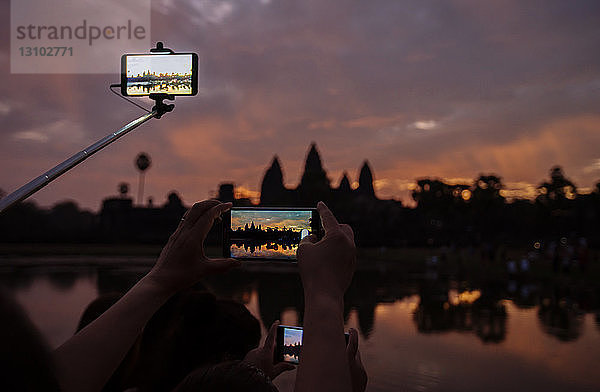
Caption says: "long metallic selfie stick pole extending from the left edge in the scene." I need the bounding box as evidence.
[0,108,162,212]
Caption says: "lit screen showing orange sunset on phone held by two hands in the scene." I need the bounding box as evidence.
[229,210,312,259]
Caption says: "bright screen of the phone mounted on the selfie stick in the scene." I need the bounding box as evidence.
[127,54,192,95]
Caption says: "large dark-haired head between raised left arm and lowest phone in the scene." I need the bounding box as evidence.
[138,289,261,391]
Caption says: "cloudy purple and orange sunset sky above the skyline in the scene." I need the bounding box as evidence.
[0,0,600,210]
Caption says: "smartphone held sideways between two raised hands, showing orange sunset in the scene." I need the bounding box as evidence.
[223,207,323,262]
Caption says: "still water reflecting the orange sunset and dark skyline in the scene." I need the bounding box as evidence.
[0,257,600,391]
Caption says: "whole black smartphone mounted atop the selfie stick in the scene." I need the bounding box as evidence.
[121,53,198,96]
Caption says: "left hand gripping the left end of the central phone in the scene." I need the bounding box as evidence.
[148,200,240,291]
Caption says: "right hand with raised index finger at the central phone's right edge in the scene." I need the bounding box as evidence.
[298,202,356,300]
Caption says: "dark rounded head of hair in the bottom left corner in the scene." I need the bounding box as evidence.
[0,290,60,392]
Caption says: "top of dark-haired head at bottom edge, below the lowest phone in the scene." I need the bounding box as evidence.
[173,361,278,392]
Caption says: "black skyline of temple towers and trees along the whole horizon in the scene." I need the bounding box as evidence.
[0,143,600,247]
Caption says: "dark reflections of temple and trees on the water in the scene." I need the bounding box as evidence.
[21,265,600,343]
